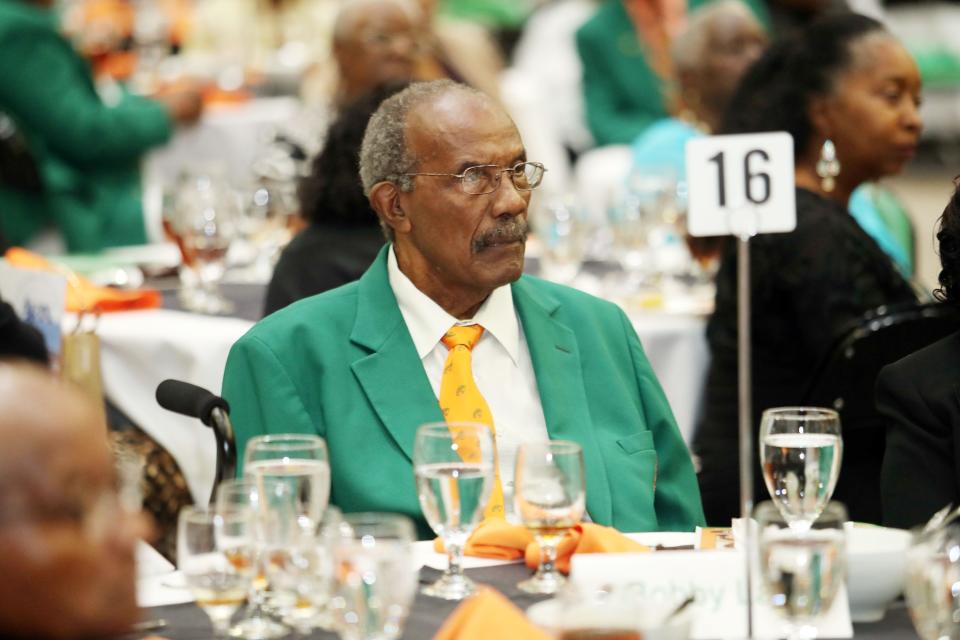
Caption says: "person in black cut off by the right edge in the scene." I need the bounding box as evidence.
[876,184,960,529]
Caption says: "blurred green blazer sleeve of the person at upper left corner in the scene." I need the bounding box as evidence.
[0,8,172,168]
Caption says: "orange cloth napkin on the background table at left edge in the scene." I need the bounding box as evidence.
[5,247,163,312]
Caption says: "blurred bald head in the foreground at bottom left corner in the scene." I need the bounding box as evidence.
[0,363,148,639]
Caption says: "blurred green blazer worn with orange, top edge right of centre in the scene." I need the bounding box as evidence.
[576,0,769,146]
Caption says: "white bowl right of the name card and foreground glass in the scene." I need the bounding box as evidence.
[847,525,912,622]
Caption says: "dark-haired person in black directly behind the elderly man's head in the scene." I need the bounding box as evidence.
[264,84,403,315]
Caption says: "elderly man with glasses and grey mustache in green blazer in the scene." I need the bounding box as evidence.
[223,81,703,536]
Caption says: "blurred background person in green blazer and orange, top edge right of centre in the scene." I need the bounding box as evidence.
[577,0,767,146]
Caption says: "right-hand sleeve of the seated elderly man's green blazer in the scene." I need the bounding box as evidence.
[621,312,705,531]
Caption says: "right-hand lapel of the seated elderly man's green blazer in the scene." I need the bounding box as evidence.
[513,277,613,522]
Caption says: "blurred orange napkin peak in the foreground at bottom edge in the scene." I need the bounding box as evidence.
[433,587,550,640]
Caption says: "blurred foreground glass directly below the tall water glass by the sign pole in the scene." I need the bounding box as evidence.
[754,501,847,640]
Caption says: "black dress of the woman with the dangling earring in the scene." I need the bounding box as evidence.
[693,188,916,526]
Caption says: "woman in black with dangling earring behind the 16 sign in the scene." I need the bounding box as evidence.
[692,14,921,526]
